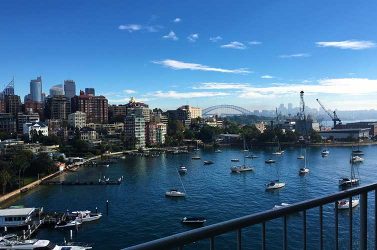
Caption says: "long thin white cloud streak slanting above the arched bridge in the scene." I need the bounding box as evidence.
[153,59,251,74]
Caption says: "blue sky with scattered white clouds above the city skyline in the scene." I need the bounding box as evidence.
[0,0,377,110]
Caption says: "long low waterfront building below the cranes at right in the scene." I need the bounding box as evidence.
[320,128,370,140]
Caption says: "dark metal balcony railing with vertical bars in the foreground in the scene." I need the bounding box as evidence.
[125,183,377,250]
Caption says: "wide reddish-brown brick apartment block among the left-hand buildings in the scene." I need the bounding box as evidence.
[71,91,109,123]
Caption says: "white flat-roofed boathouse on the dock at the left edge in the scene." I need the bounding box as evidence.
[0,208,36,227]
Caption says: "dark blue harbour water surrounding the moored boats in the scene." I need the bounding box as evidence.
[2,146,377,249]
